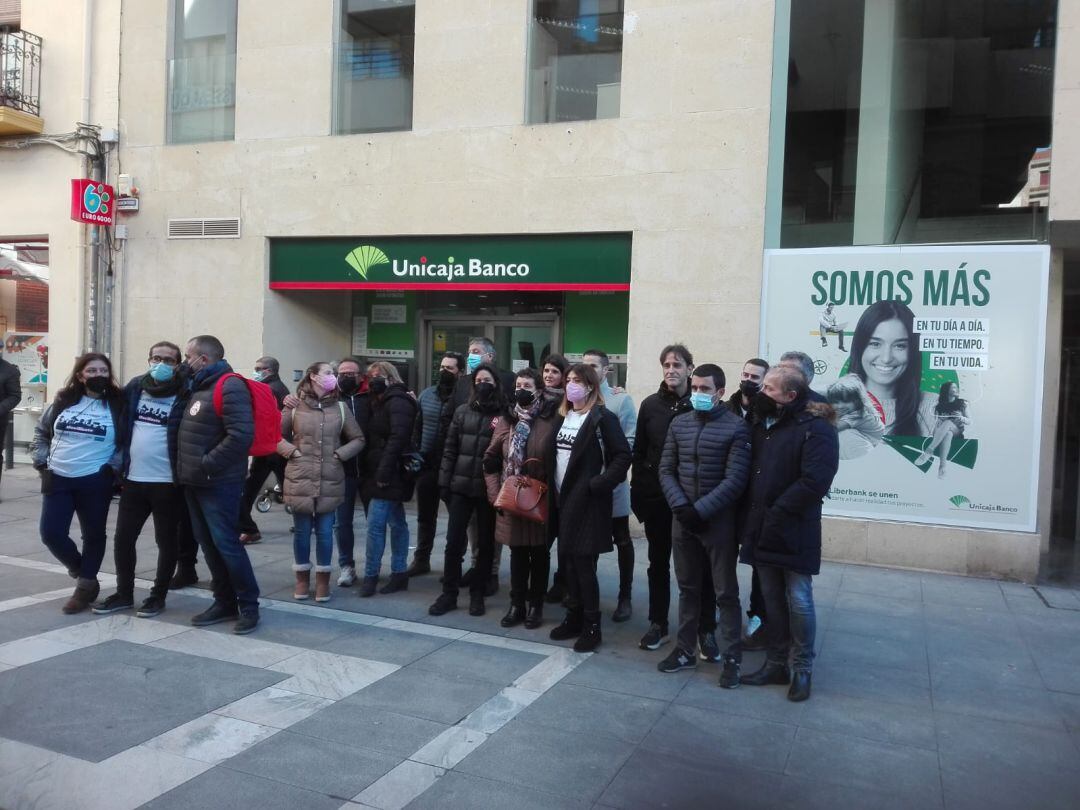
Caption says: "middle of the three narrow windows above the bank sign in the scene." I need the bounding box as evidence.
[334,0,416,135]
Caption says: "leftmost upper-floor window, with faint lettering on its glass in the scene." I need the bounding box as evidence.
[166,0,237,144]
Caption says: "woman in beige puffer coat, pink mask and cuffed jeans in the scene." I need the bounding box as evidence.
[278,362,364,602]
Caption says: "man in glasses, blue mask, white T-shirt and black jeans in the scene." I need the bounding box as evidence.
[92,340,188,618]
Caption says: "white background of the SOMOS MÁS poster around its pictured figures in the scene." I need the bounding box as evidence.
[761,245,1050,531]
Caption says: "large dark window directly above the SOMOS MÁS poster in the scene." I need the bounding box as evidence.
[767,0,1056,247]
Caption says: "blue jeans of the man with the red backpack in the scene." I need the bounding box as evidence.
[184,481,259,613]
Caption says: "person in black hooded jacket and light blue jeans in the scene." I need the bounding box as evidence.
[360,360,417,597]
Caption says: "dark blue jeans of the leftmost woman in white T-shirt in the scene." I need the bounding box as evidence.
[40,468,112,579]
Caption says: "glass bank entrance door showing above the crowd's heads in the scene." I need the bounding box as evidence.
[419,312,561,388]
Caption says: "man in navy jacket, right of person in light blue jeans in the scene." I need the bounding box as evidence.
[407,352,465,577]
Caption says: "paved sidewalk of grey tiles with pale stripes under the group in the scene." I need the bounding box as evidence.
[0,468,1080,810]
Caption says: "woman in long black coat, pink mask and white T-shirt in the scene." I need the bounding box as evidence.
[548,363,631,652]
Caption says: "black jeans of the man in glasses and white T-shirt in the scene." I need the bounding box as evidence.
[112,481,187,598]
